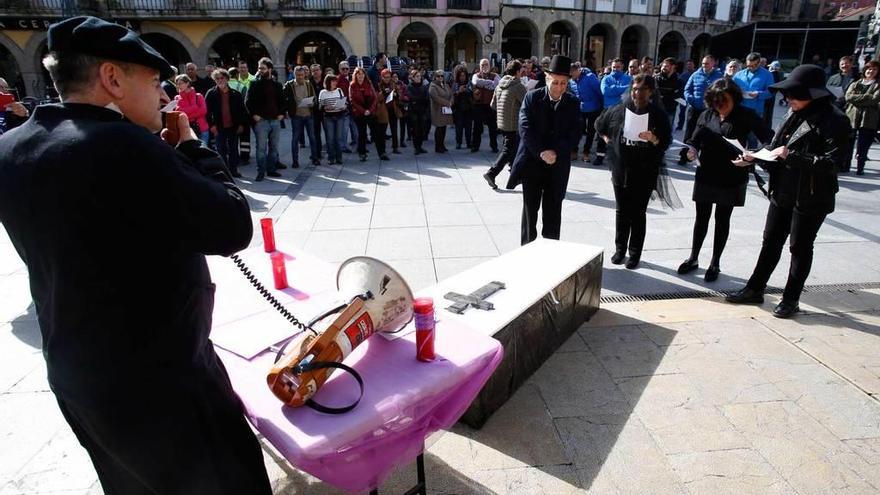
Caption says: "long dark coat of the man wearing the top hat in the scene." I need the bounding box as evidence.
[507,87,581,192]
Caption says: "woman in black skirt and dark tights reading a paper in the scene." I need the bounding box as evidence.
[678,78,773,282]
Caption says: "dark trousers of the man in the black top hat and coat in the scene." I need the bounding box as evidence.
[520,172,566,246]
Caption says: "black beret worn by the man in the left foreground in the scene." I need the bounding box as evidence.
[49,16,174,79]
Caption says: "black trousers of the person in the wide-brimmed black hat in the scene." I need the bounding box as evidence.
[746,203,825,302]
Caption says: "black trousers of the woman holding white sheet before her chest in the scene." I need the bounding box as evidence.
[614,179,657,258]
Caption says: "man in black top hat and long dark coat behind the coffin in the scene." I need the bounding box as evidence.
[507,55,580,245]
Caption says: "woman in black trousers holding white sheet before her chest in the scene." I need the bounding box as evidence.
[596,74,672,270]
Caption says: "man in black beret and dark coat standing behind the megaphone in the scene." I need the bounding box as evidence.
[0,17,271,495]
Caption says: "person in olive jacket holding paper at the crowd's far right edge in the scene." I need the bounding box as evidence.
[846,60,880,175]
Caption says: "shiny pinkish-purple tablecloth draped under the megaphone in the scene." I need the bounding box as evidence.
[211,246,503,492]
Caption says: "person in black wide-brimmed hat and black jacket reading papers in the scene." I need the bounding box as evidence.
[727,65,851,318]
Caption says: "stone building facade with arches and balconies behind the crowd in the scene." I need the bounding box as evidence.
[0,0,753,97]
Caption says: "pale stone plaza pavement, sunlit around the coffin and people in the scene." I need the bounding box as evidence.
[0,117,880,495]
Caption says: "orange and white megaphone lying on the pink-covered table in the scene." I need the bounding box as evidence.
[266,256,413,412]
